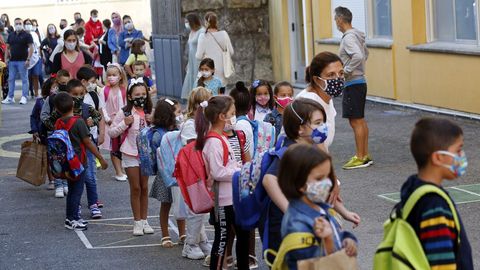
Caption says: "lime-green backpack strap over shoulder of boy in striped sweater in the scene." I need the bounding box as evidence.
[402,184,460,243]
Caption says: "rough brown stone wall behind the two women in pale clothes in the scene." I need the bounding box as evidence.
[182,0,273,84]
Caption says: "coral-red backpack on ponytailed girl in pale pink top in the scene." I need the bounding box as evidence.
[173,132,229,214]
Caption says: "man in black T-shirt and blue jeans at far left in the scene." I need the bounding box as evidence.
[2,18,33,104]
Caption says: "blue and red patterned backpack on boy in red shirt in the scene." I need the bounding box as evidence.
[47,116,86,181]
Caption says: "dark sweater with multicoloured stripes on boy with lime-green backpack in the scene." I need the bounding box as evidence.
[400,175,473,270]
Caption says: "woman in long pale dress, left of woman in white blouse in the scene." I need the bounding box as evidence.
[182,13,205,99]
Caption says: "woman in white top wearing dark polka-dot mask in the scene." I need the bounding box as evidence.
[296,52,345,151]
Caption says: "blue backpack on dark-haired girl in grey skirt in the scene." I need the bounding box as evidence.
[137,127,166,176]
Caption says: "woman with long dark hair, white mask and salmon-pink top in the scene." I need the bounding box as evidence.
[52,29,92,79]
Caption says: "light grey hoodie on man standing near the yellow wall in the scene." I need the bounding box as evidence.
[339,28,368,83]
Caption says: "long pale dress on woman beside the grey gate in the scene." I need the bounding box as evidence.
[182,27,205,99]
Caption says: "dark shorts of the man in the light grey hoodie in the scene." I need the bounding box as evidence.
[342,83,367,119]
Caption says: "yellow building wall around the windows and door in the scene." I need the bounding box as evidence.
[270,0,480,114]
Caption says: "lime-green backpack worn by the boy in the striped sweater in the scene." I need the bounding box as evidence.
[373,184,460,270]
